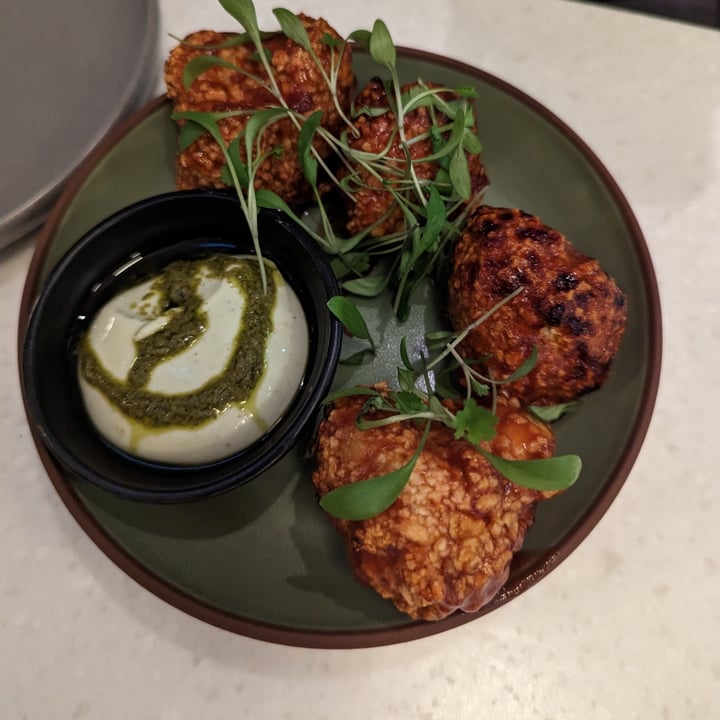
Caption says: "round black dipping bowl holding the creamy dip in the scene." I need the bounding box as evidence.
[21,190,342,502]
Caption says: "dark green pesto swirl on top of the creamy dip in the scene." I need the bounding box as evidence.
[78,254,276,428]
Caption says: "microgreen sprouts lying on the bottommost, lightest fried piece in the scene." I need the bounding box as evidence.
[320,296,582,520]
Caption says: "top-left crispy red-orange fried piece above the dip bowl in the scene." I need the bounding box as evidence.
[165,15,355,206]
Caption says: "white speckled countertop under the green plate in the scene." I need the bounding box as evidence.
[0,0,720,720]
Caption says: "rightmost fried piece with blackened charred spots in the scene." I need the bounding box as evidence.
[448,206,627,405]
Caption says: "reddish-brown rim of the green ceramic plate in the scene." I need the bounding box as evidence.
[18,47,662,649]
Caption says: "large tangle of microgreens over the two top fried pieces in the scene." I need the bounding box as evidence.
[173,0,482,320]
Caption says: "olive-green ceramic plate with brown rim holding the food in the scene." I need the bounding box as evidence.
[20,50,661,647]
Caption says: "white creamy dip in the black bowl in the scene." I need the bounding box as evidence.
[78,255,309,465]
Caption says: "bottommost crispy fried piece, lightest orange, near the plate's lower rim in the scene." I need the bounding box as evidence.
[313,385,555,620]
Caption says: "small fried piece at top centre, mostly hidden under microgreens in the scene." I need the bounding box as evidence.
[347,78,488,237]
